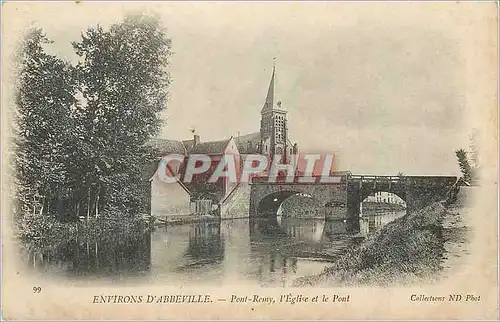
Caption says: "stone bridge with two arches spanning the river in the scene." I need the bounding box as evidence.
[249,174,457,219]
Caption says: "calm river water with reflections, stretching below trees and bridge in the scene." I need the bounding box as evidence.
[28,213,404,286]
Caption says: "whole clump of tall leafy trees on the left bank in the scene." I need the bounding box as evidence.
[15,15,171,228]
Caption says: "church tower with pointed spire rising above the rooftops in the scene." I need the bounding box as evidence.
[260,66,289,163]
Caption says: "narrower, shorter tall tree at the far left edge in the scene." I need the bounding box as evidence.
[15,28,76,221]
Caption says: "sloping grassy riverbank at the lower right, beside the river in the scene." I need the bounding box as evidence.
[294,190,468,286]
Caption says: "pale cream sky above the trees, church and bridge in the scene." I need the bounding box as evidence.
[2,2,496,175]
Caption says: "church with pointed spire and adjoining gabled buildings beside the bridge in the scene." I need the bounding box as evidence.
[146,66,298,220]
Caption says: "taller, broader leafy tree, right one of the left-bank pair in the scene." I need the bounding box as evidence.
[73,15,171,216]
